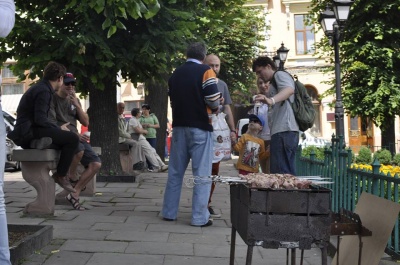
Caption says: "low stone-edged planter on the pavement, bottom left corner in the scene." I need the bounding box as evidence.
[8,224,53,264]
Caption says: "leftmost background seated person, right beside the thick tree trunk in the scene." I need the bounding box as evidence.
[117,102,145,170]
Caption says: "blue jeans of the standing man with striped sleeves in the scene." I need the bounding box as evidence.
[162,127,213,225]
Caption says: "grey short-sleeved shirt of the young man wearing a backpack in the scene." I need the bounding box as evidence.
[268,71,299,136]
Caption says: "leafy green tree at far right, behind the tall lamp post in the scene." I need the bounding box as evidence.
[312,0,400,146]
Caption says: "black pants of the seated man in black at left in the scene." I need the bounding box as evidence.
[32,128,79,176]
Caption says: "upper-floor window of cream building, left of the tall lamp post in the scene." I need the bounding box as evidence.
[294,15,315,55]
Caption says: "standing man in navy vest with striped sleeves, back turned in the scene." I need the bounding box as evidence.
[162,42,221,227]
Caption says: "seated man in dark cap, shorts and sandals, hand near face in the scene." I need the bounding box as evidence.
[50,73,101,210]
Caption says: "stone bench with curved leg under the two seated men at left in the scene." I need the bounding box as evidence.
[12,147,101,216]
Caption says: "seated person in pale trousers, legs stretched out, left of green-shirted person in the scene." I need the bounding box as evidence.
[128,108,168,172]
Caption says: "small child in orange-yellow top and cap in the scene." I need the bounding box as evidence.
[232,114,269,175]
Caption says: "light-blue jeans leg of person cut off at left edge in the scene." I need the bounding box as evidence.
[0,104,11,265]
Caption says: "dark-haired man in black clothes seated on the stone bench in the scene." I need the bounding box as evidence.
[8,62,79,192]
